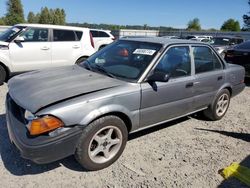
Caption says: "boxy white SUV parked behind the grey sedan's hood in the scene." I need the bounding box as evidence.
[0,24,96,84]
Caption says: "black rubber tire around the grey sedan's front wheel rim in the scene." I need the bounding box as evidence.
[75,116,128,170]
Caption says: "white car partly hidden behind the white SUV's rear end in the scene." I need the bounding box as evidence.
[90,29,115,50]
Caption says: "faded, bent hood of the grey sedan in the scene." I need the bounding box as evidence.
[8,65,123,113]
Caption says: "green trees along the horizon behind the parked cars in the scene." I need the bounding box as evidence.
[0,0,250,31]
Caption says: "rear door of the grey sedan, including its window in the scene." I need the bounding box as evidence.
[191,45,225,110]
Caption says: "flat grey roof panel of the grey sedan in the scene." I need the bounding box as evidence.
[120,37,204,46]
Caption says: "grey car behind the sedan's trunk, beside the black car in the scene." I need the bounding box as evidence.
[212,36,244,58]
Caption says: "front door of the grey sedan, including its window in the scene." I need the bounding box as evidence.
[140,46,194,127]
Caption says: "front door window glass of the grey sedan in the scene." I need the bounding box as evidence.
[155,46,191,78]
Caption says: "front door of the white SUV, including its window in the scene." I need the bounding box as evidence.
[9,27,51,72]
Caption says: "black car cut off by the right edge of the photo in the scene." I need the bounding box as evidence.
[225,41,250,77]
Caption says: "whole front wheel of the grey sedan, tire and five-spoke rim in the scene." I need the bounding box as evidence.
[75,115,128,170]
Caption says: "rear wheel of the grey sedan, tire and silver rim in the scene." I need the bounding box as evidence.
[203,89,230,121]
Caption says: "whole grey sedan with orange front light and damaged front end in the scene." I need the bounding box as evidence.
[6,37,245,170]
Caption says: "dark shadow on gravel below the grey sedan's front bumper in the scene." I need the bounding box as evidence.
[0,114,85,176]
